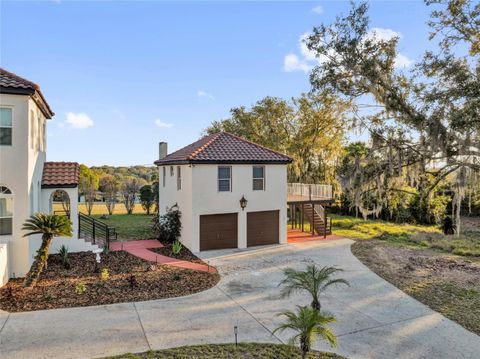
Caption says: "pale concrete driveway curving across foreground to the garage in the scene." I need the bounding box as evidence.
[0,239,480,359]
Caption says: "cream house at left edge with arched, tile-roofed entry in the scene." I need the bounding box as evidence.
[0,69,98,286]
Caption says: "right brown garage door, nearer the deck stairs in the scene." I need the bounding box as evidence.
[247,211,279,247]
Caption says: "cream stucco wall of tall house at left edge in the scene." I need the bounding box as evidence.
[0,94,46,277]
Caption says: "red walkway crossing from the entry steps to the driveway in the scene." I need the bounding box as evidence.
[110,239,217,273]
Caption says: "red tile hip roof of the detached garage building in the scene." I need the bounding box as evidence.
[155,132,292,165]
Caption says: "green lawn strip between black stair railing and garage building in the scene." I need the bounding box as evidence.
[93,214,154,241]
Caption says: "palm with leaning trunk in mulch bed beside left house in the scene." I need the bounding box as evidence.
[22,213,72,287]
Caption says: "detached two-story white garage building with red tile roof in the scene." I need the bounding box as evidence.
[155,132,292,252]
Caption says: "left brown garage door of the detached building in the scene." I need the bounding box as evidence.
[200,213,238,251]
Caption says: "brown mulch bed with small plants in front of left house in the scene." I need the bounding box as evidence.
[0,251,220,312]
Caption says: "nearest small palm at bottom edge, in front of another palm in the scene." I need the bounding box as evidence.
[273,305,337,359]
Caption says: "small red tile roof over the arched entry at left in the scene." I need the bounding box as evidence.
[42,162,80,188]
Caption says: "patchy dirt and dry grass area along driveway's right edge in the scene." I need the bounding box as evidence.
[352,239,480,335]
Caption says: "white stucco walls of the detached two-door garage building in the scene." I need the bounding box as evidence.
[159,164,287,252]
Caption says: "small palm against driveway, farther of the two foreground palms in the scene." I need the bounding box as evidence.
[279,265,350,310]
